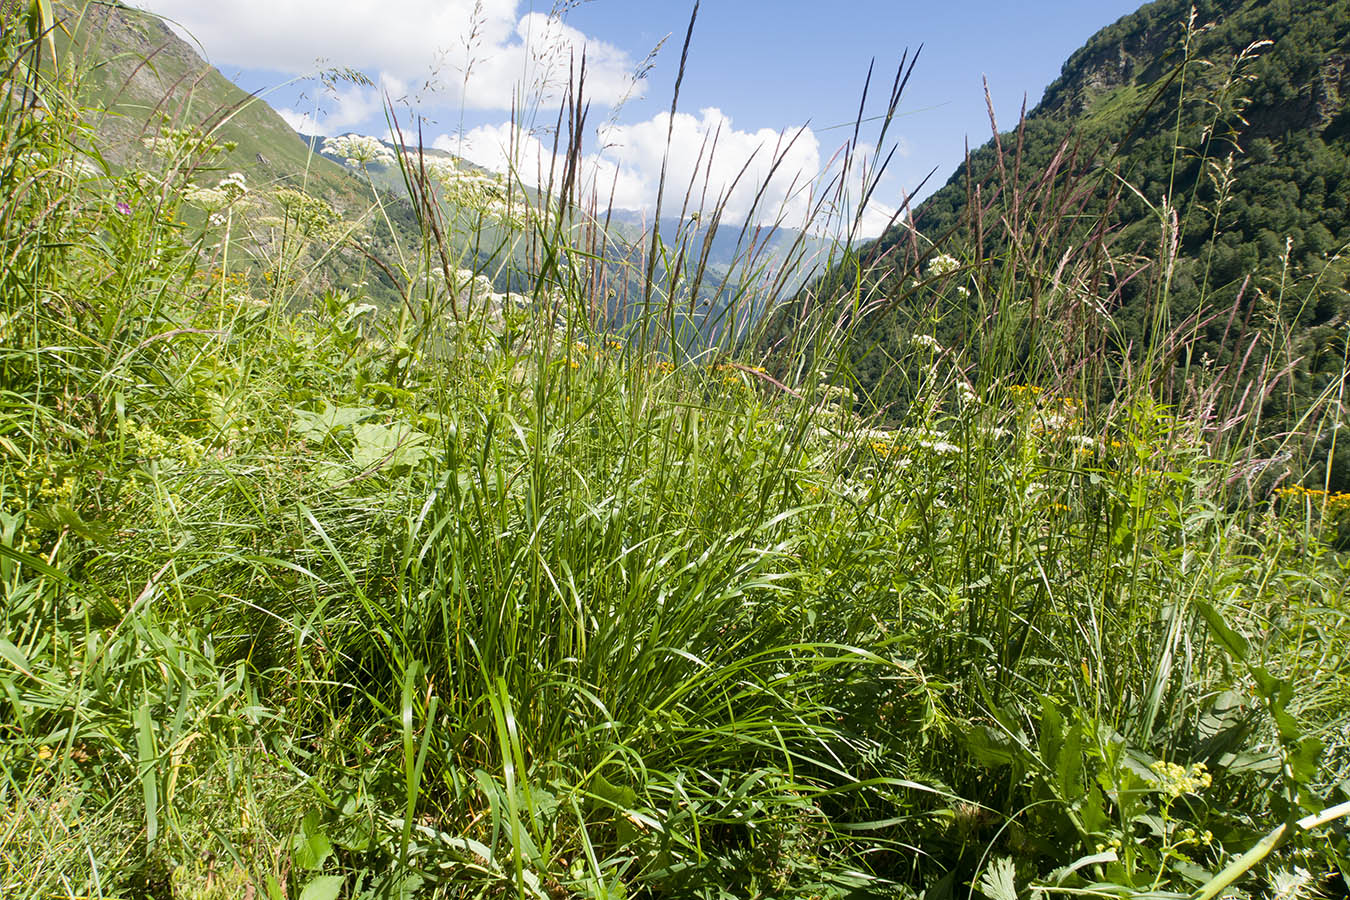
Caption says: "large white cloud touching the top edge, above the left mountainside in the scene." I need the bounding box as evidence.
[139,0,636,109]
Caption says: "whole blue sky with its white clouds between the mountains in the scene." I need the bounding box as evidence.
[139,0,1139,231]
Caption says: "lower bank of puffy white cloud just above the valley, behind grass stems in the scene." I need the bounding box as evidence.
[435,108,894,236]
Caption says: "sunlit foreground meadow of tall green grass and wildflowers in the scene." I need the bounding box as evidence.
[0,1,1350,900]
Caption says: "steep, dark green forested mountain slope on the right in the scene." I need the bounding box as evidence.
[793,0,1350,485]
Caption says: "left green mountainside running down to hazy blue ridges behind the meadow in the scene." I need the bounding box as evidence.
[68,0,828,335]
